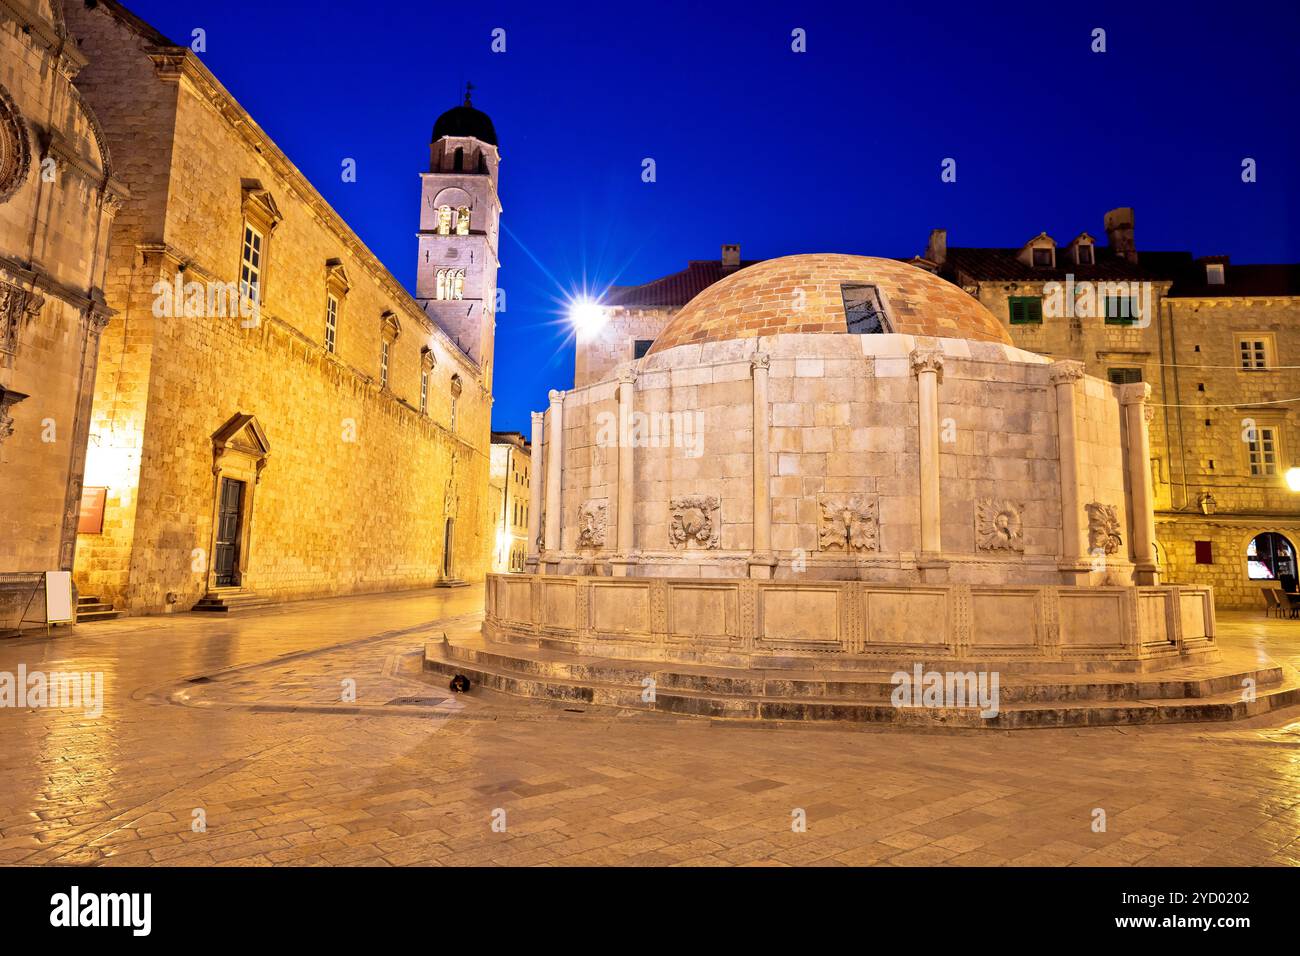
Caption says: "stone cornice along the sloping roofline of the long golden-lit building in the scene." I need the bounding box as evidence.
[138,46,482,380]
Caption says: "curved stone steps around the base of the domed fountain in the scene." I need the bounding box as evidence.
[424,641,1300,730]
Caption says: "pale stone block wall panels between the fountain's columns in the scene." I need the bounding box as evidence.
[538,333,1132,584]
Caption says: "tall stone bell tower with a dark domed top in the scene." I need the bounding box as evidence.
[416,83,501,377]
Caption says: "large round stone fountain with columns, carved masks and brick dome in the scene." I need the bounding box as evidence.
[429,255,1300,726]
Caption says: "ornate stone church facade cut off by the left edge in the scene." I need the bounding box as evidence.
[0,0,124,631]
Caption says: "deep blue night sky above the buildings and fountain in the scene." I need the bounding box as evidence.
[114,0,1300,432]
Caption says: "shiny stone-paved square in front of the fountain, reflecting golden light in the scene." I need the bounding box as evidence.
[0,588,1300,866]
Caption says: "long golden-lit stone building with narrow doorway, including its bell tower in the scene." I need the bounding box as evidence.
[65,0,499,613]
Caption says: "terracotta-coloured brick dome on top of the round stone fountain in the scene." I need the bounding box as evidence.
[650,254,1011,354]
